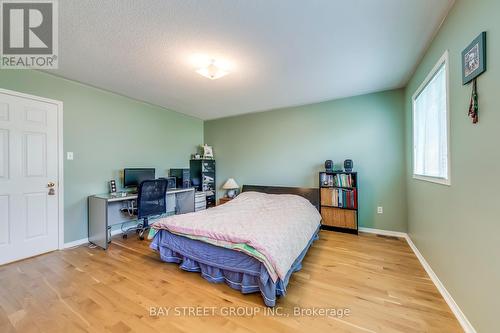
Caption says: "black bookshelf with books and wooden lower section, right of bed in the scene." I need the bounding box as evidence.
[319,171,358,234]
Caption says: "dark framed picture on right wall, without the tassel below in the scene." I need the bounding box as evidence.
[462,31,486,84]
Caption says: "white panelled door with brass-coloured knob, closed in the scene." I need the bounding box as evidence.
[0,91,59,265]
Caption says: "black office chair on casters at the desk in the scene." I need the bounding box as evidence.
[123,179,168,240]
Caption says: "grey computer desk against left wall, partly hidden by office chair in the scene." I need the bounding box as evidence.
[88,188,195,250]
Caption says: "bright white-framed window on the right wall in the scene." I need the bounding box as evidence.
[413,52,450,185]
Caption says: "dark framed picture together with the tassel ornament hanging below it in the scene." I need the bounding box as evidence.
[462,31,486,124]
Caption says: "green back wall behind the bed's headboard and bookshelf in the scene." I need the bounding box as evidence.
[205,90,406,231]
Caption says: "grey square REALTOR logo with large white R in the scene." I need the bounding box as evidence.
[0,0,58,69]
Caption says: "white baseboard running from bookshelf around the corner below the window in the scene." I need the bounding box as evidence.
[359,227,477,333]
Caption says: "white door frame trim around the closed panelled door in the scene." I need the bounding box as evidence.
[0,88,64,250]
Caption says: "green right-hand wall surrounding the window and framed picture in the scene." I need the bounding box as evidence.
[406,0,500,332]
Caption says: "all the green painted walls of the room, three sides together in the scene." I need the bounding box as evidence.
[0,0,494,326]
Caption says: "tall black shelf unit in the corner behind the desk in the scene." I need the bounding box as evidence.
[189,159,217,208]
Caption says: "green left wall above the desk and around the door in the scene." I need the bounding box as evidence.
[0,70,203,242]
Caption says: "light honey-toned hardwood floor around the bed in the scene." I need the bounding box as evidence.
[0,231,462,333]
